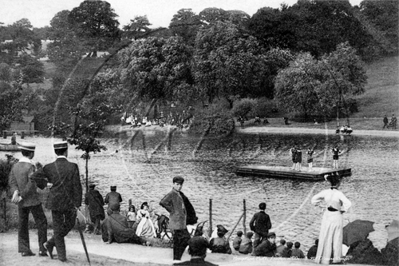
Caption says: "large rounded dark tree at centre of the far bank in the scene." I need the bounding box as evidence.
[193,21,266,106]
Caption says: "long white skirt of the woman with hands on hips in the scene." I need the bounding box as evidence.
[316,210,343,264]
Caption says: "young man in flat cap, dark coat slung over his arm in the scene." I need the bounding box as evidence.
[159,176,198,260]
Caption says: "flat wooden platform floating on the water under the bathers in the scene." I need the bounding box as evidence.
[236,165,352,181]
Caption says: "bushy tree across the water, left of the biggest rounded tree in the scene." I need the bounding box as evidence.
[119,37,193,104]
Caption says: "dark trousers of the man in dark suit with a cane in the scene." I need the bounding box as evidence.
[48,209,76,260]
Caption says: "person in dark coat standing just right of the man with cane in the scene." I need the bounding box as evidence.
[85,184,105,235]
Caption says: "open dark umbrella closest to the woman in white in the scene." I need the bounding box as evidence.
[343,220,374,246]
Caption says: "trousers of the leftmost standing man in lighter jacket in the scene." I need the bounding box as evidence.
[18,204,47,253]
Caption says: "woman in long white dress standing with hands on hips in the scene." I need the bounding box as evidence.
[311,172,352,264]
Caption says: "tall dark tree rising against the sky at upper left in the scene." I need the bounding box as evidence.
[68,0,120,57]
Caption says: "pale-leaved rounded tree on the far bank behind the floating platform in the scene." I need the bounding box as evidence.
[275,43,366,119]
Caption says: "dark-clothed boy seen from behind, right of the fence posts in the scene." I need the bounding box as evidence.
[249,202,272,249]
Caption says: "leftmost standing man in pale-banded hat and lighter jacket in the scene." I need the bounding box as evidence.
[9,143,47,257]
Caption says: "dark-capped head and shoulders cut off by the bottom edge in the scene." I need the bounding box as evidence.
[173,236,218,266]
